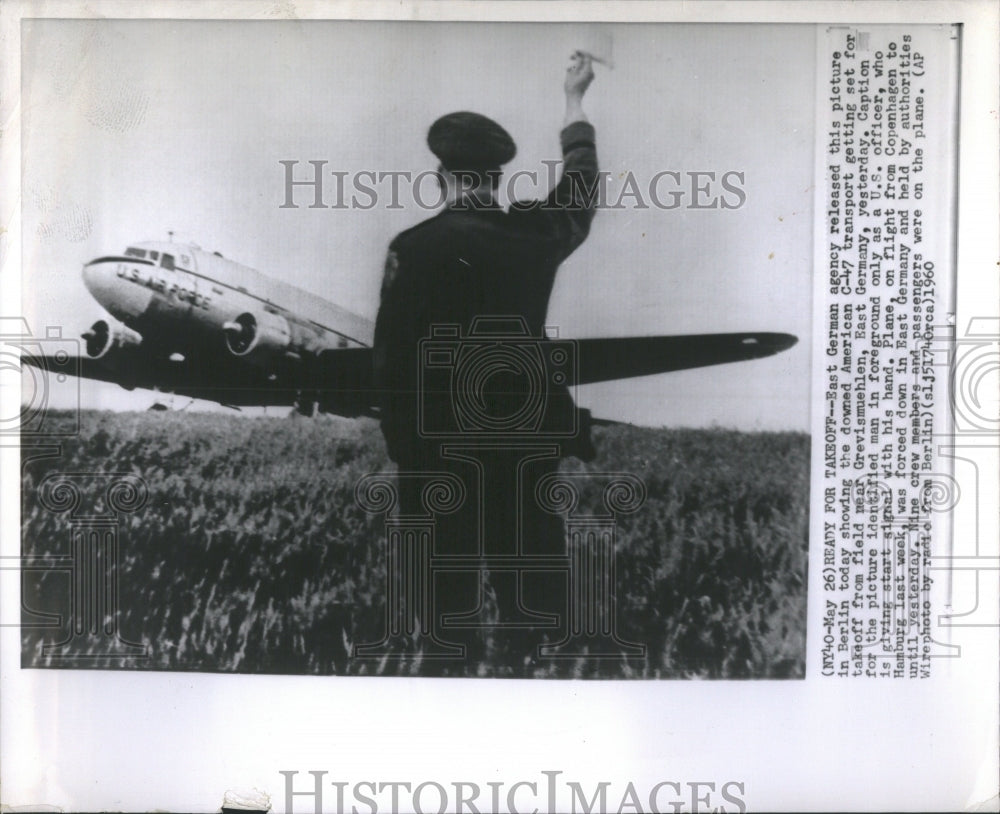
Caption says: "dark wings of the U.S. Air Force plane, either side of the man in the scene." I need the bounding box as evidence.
[22,333,798,416]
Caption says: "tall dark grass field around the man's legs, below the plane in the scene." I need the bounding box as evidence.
[22,413,809,678]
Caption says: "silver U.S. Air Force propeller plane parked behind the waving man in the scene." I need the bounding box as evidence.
[23,242,797,416]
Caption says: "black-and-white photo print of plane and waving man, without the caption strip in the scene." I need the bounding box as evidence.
[15,20,815,679]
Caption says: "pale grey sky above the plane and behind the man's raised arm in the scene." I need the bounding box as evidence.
[22,20,815,430]
